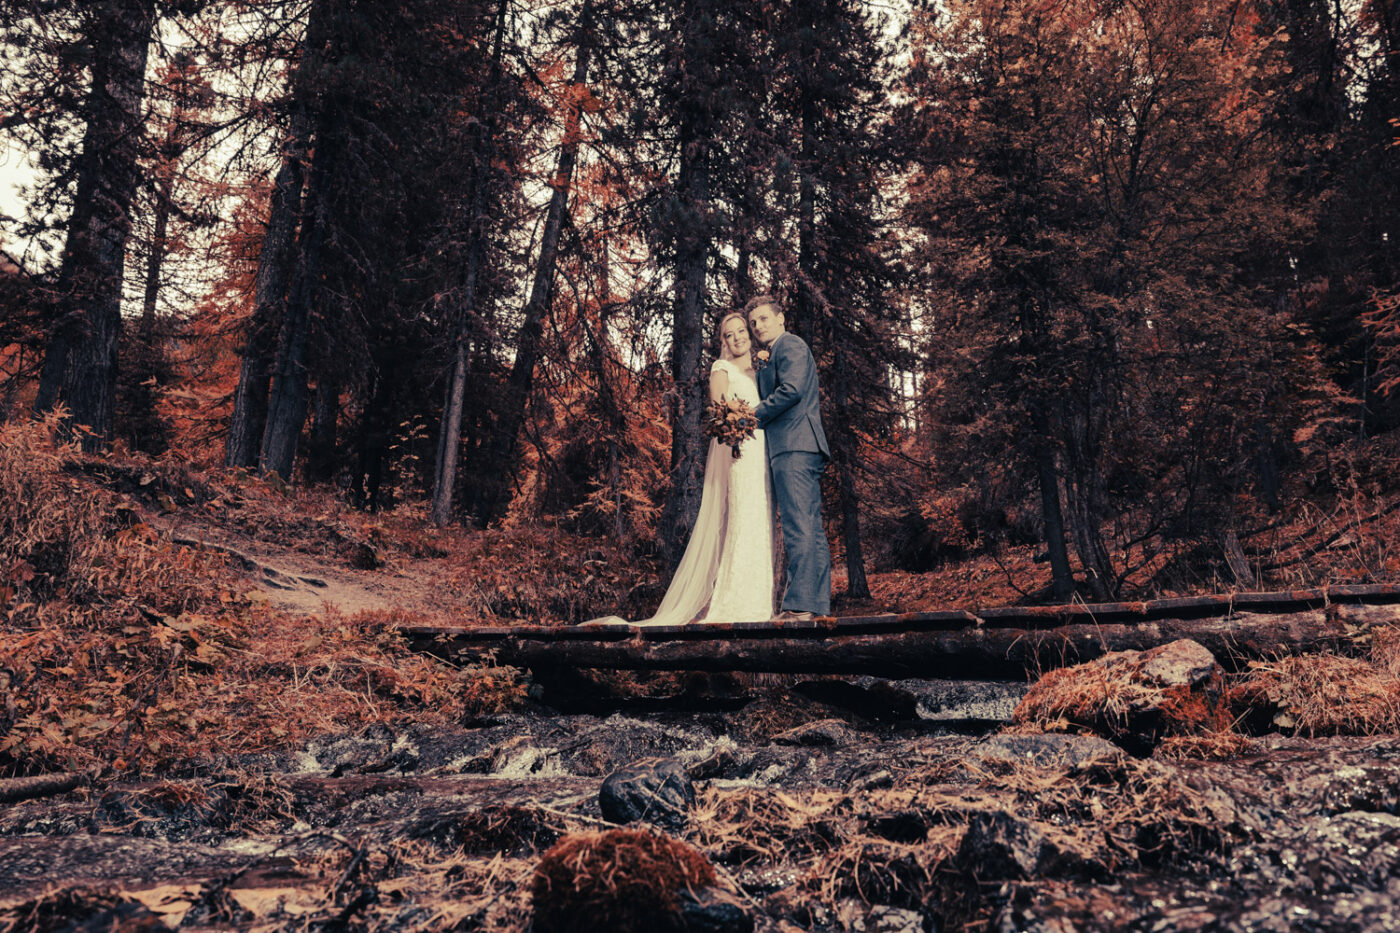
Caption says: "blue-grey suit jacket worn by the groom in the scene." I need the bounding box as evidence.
[753,333,832,459]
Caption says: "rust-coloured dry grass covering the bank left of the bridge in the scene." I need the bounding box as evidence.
[0,422,524,776]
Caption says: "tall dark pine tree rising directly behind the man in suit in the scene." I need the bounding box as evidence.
[771,0,910,598]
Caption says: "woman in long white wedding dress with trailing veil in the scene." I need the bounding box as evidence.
[585,311,774,625]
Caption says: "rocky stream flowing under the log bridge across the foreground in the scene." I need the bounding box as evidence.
[0,678,1400,933]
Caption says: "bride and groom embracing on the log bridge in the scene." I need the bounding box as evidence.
[598,296,832,625]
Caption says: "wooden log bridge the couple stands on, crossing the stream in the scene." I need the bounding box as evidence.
[402,584,1400,679]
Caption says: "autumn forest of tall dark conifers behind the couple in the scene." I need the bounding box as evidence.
[0,0,1400,600]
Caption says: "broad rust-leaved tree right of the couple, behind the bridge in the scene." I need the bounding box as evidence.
[910,0,1327,598]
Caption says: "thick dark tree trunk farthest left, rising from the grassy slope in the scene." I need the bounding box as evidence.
[35,0,157,450]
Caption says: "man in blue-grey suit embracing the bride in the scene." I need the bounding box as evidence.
[743,294,832,619]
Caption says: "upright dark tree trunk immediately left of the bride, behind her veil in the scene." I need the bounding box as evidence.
[658,104,710,565]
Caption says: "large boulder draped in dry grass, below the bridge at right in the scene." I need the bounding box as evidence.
[1012,639,1232,755]
